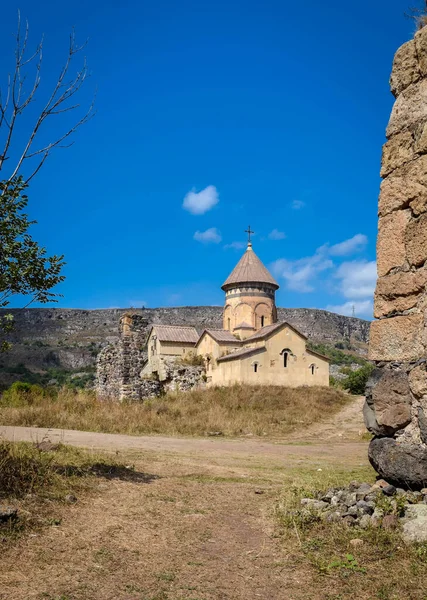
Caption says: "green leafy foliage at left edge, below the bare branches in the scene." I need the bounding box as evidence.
[0,177,64,351]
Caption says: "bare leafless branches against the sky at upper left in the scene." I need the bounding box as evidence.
[0,11,94,194]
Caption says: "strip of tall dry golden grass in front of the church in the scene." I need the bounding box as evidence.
[0,385,349,436]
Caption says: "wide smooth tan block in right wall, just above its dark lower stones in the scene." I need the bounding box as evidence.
[369,313,425,362]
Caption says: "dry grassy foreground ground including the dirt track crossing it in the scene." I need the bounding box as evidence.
[0,392,427,600]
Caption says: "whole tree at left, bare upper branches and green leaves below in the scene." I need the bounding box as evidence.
[0,12,93,352]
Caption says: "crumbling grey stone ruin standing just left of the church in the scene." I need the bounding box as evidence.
[96,312,204,401]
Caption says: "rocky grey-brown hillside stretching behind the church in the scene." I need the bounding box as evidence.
[0,306,369,384]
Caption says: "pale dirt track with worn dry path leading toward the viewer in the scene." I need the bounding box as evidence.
[0,398,367,600]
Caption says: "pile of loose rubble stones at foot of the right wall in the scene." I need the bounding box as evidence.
[297,479,427,542]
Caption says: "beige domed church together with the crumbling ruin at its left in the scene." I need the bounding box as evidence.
[97,240,329,399]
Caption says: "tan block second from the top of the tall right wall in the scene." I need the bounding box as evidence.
[386,79,427,139]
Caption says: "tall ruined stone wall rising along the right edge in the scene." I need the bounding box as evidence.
[364,27,427,488]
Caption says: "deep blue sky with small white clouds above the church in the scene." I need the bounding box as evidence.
[0,0,422,317]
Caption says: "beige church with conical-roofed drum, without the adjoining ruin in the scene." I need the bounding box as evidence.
[142,241,329,387]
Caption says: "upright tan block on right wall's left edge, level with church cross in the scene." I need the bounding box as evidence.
[377,210,410,277]
